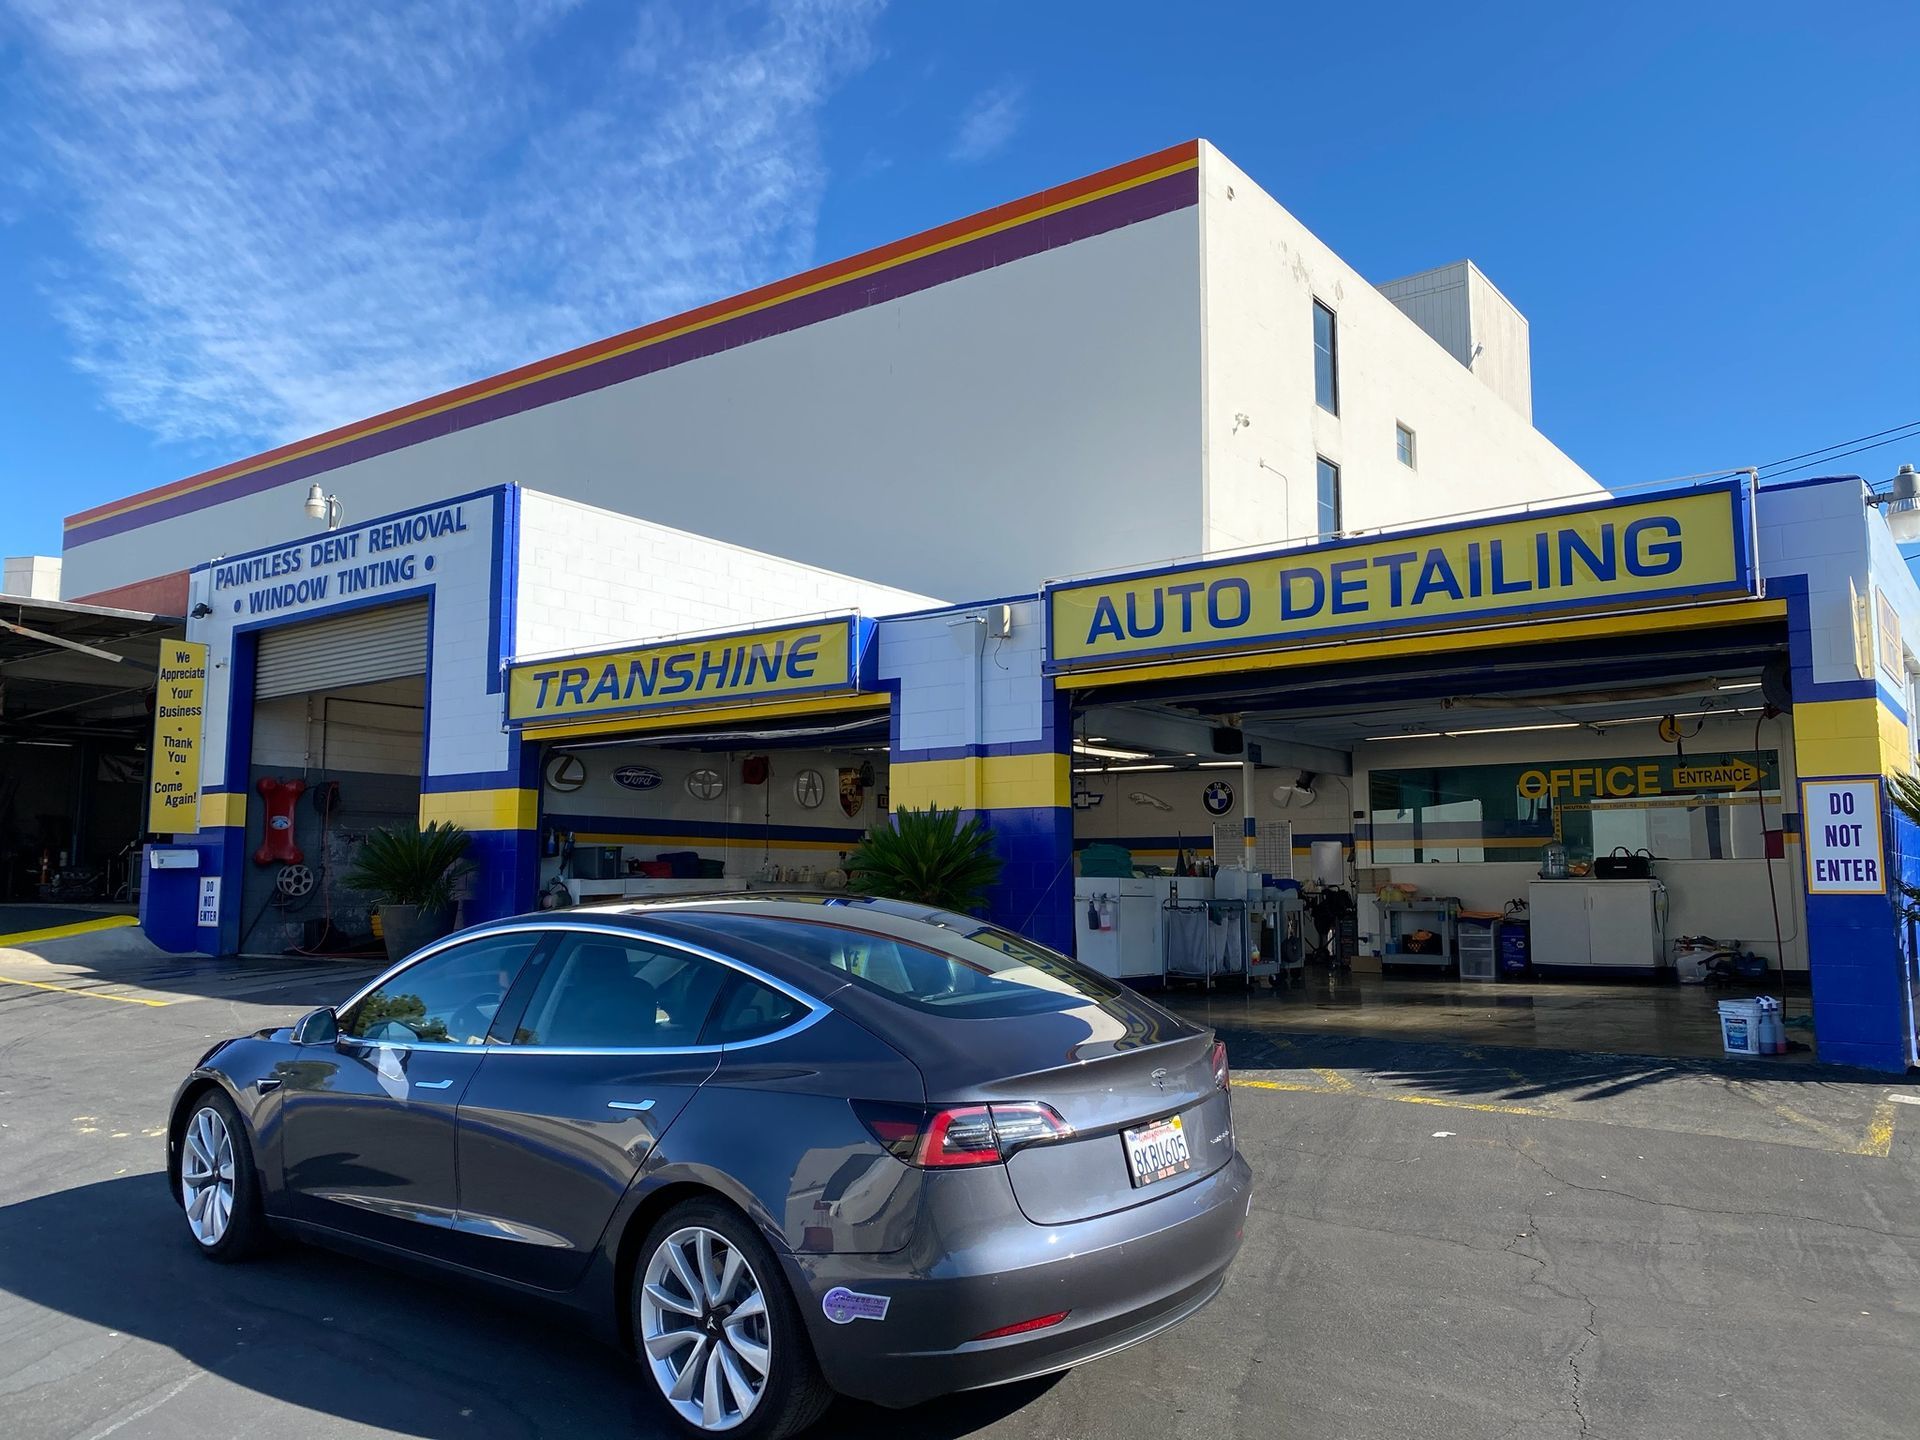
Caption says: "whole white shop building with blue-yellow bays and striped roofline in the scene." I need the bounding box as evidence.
[65,144,1920,1069]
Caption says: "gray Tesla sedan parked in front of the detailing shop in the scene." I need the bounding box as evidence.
[167,897,1252,1438]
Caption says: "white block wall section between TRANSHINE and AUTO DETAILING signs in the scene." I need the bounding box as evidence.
[879,599,1050,751]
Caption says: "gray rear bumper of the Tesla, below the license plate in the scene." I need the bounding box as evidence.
[787,1154,1254,1407]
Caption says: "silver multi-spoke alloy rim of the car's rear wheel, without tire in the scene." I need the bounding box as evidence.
[639,1225,774,1432]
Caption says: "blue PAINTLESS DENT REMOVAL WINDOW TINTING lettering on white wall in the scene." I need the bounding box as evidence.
[209,503,472,618]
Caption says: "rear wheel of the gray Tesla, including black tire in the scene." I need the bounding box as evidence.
[632,1200,833,1440]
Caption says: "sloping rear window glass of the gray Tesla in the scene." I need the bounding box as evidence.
[698,914,1119,1020]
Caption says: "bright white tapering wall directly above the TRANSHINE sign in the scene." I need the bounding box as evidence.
[513,490,939,657]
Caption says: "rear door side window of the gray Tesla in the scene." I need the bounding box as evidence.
[513,933,732,1050]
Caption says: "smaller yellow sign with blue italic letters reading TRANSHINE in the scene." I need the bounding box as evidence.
[507,616,858,724]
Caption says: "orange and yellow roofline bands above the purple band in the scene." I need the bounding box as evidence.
[65,140,1200,530]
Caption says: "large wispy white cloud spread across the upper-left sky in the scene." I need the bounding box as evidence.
[0,0,881,444]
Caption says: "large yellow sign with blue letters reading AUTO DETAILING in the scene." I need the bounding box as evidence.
[1048,482,1753,668]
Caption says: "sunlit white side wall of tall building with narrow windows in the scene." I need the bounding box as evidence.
[1198,146,1599,555]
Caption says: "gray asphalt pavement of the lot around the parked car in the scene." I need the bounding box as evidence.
[0,933,1920,1440]
